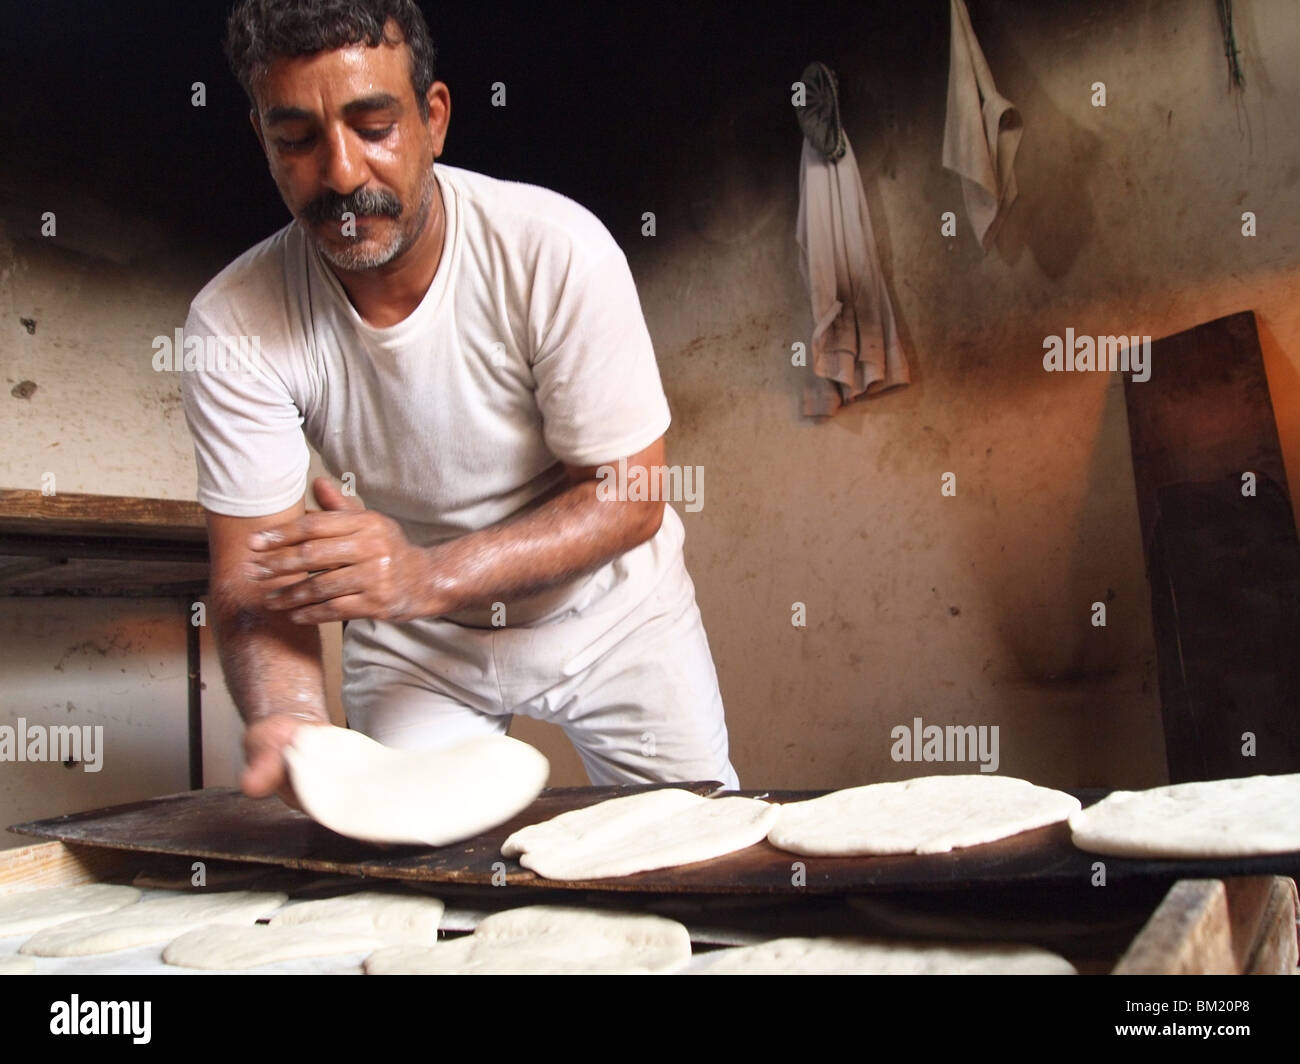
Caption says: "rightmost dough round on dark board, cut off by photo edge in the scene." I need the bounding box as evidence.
[1070,774,1300,857]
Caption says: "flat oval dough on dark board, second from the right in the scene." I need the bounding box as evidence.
[767,774,1079,857]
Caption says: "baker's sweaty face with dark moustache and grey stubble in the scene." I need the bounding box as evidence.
[254,28,450,271]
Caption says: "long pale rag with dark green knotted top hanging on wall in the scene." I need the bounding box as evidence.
[794,64,911,418]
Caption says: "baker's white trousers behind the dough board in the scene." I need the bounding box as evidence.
[343,554,740,788]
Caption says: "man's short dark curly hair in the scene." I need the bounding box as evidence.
[225,0,434,118]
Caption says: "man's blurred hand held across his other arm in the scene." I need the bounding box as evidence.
[246,476,442,624]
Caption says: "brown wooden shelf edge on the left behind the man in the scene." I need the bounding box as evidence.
[0,489,208,542]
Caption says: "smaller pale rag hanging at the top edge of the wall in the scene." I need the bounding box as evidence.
[944,0,1024,251]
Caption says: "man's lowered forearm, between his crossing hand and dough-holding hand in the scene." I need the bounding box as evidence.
[215,600,329,725]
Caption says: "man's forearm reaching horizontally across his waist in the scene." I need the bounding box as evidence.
[425,480,663,614]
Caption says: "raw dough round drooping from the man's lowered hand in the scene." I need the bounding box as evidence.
[285,725,550,845]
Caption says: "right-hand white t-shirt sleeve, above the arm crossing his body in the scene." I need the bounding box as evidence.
[533,248,671,466]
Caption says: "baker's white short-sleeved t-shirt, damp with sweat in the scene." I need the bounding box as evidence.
[181,164,683,624]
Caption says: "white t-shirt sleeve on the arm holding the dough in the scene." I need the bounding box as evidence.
[177,308,311,518]
